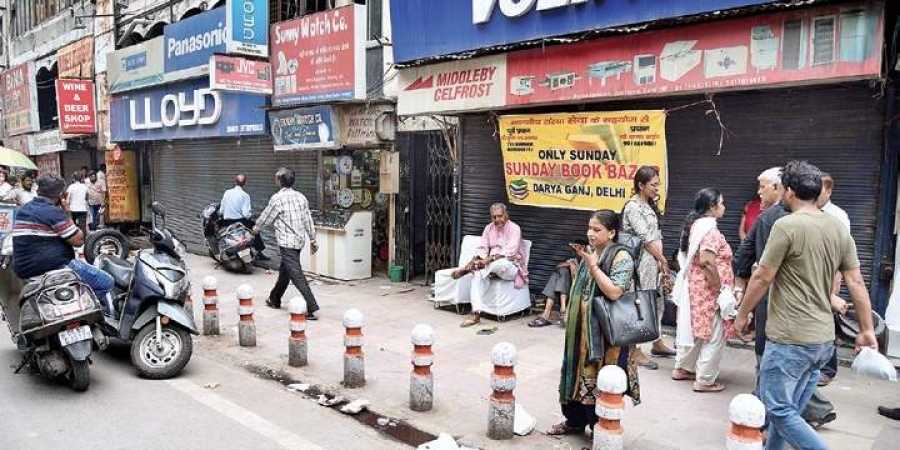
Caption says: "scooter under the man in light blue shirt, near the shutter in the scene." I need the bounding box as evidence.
[200,203,257,273]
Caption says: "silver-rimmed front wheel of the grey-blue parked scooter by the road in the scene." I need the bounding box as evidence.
[131,322,194,380]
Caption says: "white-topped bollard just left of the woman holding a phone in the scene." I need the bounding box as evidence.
[488,342,516,440]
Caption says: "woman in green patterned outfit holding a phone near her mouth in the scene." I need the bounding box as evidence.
[547,209,641,435]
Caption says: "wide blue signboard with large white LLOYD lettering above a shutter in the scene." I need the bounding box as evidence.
[109,78,268,142]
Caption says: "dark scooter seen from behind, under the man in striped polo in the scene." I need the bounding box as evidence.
[0,236,108,391]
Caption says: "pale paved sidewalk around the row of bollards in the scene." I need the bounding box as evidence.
[188,255,900,450]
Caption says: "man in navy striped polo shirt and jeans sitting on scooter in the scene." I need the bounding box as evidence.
[12,175,113,308]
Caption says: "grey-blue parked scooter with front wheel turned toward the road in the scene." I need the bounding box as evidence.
[94,202,199,379]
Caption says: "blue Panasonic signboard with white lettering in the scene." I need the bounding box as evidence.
[163,8,226,82]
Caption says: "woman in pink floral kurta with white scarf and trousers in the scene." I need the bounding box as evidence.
[672,188,735,392]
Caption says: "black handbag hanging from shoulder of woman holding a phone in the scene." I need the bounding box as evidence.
[592,244,660,347]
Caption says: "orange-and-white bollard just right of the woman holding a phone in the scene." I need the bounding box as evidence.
[593,366,628,450]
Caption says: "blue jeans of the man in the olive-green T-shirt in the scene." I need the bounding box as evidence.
[758,341,834,450]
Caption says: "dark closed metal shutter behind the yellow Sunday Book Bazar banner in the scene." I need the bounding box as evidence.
[460,82,892,292]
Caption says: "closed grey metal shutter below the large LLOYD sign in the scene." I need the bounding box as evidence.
[152,136,319,256]
